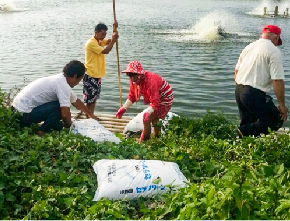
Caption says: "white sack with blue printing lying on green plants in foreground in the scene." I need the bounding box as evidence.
[93,160,188,201]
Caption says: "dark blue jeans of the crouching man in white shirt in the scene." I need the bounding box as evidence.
[19,101,63,132]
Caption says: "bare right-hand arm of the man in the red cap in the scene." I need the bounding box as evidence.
[272,80,287,120]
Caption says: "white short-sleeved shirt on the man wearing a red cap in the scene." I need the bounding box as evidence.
[236,38,285,92]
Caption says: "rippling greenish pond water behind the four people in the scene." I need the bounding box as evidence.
[0,0,290,121]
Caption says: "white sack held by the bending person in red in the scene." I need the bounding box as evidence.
[123,109,178,134]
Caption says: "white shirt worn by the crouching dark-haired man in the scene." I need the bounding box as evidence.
[12,74,77,113]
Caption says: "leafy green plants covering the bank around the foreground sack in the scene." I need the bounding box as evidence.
[0,89,290,220]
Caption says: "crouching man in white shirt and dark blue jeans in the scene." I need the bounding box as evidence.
[12,60,97,136]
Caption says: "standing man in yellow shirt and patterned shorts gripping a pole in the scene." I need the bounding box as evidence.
[83,23,118,117]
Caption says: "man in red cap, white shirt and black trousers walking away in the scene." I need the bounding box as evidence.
[234,25,287,137]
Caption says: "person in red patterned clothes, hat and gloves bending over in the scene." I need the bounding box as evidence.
[116,61,173,142]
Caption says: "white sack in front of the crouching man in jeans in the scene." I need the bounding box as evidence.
[71,118,120,144]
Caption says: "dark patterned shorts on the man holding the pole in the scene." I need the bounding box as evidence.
[83,74,102,104]
